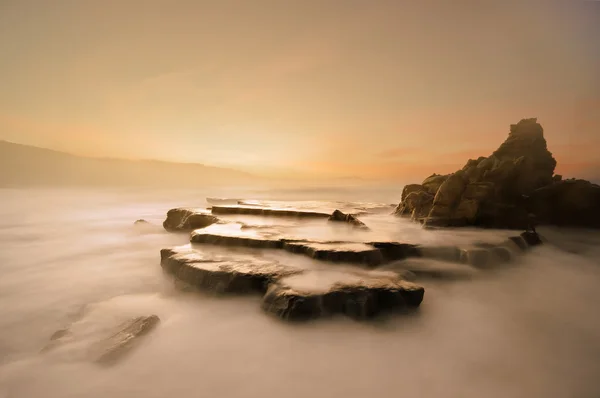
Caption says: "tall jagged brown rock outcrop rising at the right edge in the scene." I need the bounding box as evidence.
[395,118,600,229]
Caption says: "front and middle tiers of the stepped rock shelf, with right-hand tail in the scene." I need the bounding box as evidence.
[161,224,541,320]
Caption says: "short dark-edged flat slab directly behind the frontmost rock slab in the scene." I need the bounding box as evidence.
[283,241,383,266]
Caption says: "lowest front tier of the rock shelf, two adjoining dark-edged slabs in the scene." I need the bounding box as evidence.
[161,245,425,320]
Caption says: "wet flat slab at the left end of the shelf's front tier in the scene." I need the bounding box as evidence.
[160,245,301,293]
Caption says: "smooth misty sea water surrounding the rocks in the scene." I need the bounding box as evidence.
[0,187,600,398]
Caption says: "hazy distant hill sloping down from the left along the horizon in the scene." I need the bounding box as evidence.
[0,141,261,188]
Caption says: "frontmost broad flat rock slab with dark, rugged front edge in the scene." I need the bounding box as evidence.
[262,271,425,321]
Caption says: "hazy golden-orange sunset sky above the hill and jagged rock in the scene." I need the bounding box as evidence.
[0,0,600,180]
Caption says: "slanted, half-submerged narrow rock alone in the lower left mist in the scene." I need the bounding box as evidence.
[92,315,160,364]
